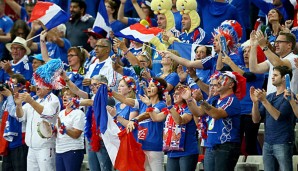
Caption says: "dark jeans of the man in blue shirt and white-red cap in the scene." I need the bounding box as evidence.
[204,142,240,171]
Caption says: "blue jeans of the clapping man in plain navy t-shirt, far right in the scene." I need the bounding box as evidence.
[263,142,294,171]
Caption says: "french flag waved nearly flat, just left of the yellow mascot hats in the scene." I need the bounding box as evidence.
[115,23,162,43]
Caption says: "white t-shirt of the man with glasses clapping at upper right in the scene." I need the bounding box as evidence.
[266,53,298,94]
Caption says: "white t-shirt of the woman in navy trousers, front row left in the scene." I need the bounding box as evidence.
[56,109,85,153]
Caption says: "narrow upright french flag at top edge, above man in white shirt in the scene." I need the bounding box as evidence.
[92,0,112,35]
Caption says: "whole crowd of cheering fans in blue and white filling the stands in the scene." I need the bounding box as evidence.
[0,0,298,171]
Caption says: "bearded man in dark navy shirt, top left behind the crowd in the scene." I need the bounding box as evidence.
[66,0,95,51]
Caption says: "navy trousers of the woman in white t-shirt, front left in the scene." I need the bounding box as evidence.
[56,150,84,171]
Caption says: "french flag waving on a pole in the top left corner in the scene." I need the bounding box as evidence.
[29,1,69,30]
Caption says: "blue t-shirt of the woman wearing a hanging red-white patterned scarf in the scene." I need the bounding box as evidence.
[167,106,199,158]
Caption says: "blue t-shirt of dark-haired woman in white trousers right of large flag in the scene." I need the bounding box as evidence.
[138,101,166,151]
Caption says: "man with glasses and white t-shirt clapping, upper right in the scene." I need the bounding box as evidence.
[249,31,298,94]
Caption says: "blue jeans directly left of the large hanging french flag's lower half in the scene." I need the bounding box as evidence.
[87,141,113,171]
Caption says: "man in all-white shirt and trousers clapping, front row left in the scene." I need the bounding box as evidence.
[15,87,60,171]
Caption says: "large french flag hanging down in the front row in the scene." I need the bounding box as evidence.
[93,85,145,171]
